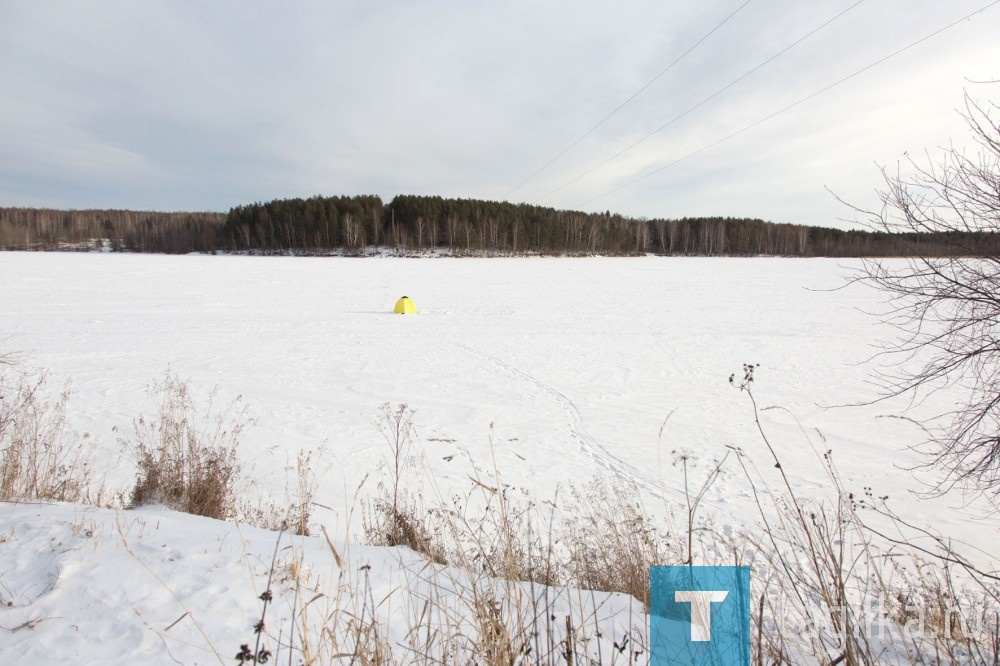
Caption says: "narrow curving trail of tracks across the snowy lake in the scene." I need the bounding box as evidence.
[455,343,666,501]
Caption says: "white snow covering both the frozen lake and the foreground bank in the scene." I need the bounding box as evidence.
[0,253,1000,663]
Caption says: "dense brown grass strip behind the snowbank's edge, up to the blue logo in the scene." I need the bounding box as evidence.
[362,406,683,608]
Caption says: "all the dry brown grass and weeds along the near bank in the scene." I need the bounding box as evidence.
[0,362,1000,666]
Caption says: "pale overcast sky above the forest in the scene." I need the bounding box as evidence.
[0,0,1000,226]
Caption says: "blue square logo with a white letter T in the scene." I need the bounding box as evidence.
[649,567,750,666]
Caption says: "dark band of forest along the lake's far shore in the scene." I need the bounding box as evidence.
[0,195,996,257]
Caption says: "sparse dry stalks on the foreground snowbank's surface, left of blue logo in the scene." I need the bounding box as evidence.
[269,520,646,666]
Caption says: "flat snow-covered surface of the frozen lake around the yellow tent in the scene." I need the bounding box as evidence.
[0,253,996,550]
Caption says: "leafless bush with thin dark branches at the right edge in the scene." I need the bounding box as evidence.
[851,88,1000,491]
